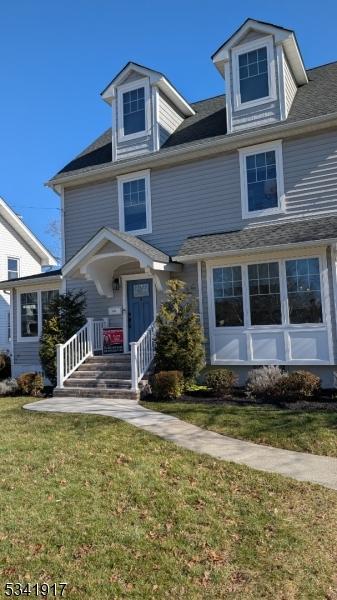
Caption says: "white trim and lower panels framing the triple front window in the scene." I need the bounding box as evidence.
[206,250,334,365]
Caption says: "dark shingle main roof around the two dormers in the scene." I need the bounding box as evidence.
[52,61,337,181]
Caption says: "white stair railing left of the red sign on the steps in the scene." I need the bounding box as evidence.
[56,318,107,388]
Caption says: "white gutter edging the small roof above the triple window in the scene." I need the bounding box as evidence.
[172,238,337,263]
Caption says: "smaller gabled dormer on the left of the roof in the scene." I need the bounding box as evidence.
[101,62,194,161]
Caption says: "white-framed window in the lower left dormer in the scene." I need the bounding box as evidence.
[118,79,151,142]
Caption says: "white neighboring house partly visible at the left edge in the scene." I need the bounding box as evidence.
[0,198,56,364]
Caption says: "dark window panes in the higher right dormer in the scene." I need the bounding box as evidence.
[239,46,269,104]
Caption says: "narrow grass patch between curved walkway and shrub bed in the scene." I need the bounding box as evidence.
[142,401,337,456]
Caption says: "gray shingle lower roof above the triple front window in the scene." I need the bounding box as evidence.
[174,216,337,260]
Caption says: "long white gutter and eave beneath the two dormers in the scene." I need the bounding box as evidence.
[45,111,337,188]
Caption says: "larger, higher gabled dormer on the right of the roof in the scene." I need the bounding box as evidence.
[212,19,308,133]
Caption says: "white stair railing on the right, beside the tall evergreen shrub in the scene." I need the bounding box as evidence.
[130,321,156,391]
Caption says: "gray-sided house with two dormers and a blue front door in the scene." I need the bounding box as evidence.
[2,19,337,394]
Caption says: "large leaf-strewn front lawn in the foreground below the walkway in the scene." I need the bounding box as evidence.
[0,398,337,600]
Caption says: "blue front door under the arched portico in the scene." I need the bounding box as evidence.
[127,279,154,343]
